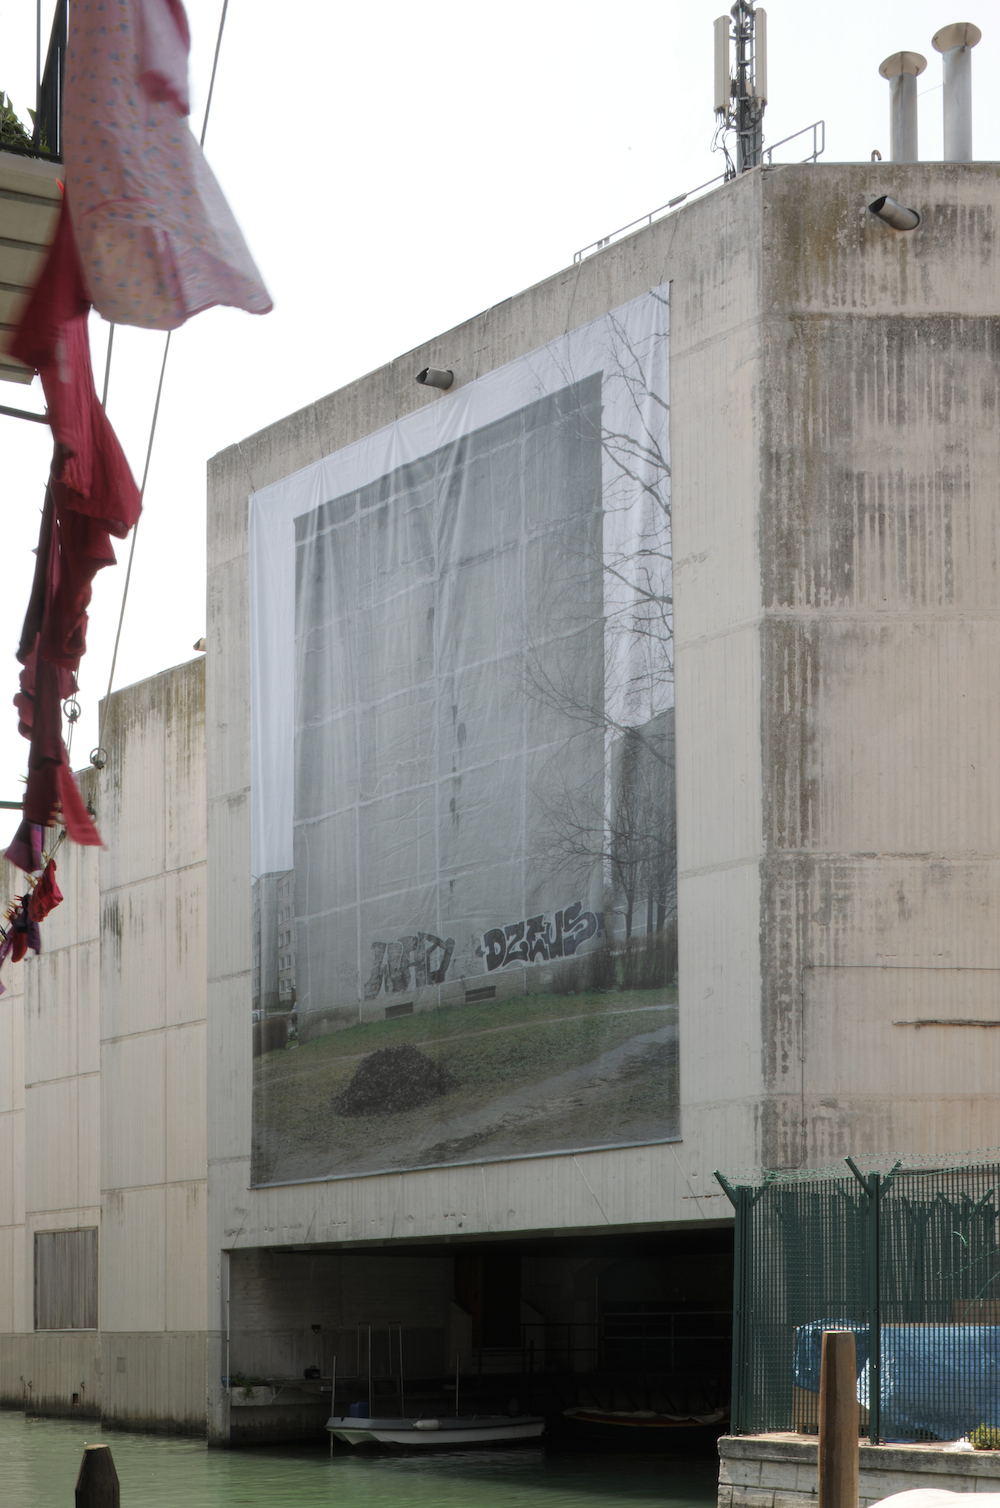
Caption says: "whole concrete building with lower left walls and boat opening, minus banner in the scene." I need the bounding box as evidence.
[0,163,1000,1443]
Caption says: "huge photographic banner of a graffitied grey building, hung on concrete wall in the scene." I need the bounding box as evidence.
[247,288,679,1185]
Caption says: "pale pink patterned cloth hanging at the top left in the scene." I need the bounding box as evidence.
[63,0,271,330]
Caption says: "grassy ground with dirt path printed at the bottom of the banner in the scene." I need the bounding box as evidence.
[253,986,677,1182]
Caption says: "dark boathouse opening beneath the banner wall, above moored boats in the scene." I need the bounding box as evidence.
[226,1224,733,1443]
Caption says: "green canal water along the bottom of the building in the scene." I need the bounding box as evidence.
[0,1411,718,1508]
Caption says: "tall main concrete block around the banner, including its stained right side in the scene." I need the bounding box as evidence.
[208,164,1000,1434]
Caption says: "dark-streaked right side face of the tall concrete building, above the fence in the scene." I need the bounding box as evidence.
[757,164,1000,1166]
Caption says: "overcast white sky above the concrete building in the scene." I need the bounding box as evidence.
[0,0,1000,843]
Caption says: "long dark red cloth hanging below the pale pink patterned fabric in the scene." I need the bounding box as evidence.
[8,199,142,861]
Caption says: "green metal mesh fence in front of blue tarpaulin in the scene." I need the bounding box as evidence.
[716,1158,1000,1442]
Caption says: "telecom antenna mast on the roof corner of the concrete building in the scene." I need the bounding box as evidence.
[715,0,768,178]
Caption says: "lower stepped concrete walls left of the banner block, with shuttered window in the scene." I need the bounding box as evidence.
[0,659,207,1433]
